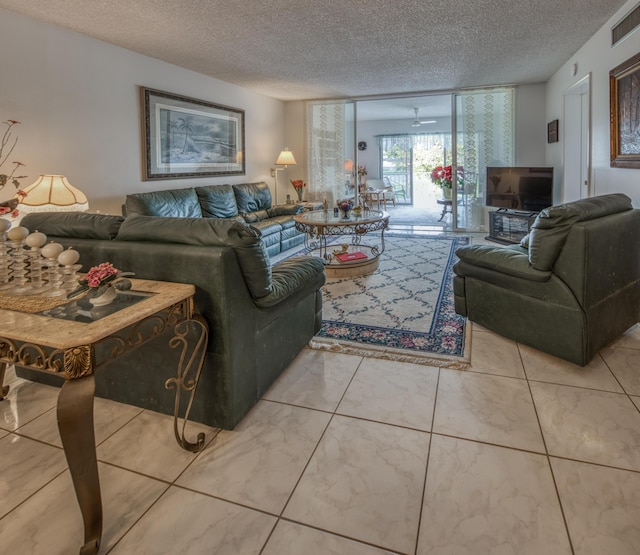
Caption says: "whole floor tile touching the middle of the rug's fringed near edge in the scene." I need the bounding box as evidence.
[337,358,438,432]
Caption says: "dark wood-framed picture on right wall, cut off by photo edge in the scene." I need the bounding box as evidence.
[609,54,640,168]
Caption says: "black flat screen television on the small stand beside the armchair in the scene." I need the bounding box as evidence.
[486,167,553,212]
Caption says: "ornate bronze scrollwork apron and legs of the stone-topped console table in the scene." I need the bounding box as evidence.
[0,299,208,555]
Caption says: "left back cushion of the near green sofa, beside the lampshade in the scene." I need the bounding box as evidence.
[20,212,124,239]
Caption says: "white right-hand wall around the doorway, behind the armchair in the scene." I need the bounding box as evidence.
[547,0,640,207]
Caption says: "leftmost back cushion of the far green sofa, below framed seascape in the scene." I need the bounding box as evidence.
[124,187,202,218]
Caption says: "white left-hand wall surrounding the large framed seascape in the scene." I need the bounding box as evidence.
[0,10,285,214]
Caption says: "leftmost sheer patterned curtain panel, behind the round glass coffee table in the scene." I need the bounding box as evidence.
[307,101,347,206]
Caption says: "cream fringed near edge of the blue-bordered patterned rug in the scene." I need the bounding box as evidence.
[308,330,471,370]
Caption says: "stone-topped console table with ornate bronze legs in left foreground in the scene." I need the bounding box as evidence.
[0,280,208,554]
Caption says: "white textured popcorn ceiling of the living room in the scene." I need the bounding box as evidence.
[0,0,625,100]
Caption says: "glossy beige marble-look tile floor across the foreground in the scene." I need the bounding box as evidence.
[0,326,640,555]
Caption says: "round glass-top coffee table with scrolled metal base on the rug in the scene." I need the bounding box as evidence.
[293,210,389,277]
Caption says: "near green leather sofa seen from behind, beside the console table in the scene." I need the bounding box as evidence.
[17,213,325,429]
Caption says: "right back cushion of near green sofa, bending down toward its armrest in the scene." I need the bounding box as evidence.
[116,216,271,299]
